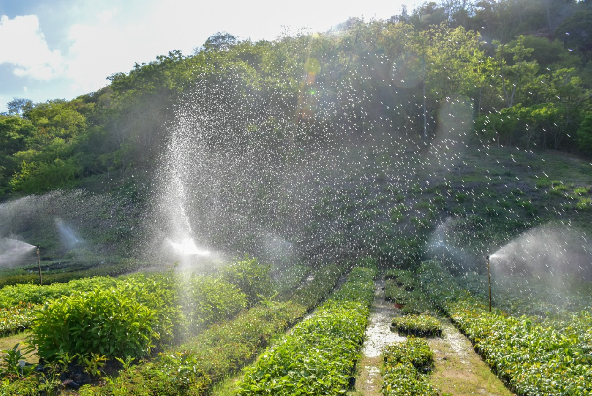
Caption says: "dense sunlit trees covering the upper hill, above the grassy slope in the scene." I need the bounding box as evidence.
[0,0,592,198]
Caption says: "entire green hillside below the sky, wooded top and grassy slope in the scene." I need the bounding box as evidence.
[0,1,592,273]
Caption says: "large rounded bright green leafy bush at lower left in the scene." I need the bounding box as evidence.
[27,288,159,362]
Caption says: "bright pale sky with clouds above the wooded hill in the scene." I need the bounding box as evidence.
[0,0,422,112]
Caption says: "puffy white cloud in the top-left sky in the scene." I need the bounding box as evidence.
[0,15,63,81]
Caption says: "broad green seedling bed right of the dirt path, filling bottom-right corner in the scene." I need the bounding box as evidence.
[419,261,592,395]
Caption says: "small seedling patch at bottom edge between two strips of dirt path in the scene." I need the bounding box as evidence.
[382,337,439,396]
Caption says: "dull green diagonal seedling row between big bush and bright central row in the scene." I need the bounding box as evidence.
[74,265,341,395]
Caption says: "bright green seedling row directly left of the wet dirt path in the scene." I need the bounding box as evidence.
[237,268,375,396]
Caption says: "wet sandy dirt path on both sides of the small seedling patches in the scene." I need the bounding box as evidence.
[350,281,513,396]
